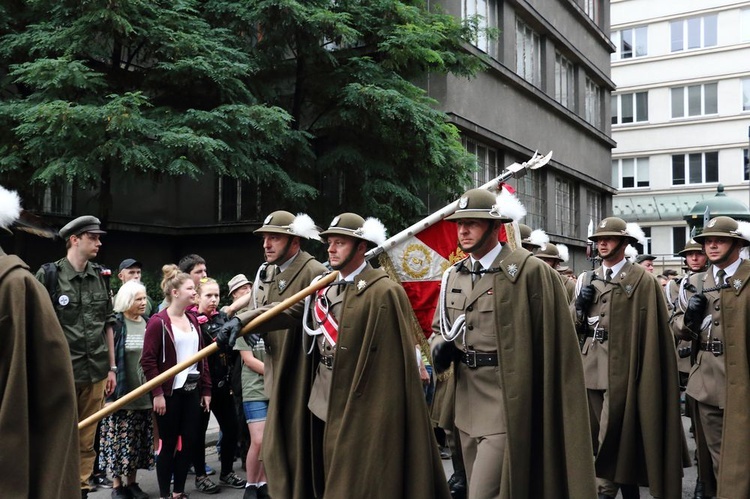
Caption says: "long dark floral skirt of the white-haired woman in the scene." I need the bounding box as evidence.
[99,409,154,477]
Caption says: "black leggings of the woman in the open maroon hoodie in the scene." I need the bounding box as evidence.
[156,388,203,497]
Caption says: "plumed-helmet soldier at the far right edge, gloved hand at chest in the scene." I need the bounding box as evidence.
[674,216,750,497]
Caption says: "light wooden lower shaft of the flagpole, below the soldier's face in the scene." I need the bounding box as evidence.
[78,271,339,430]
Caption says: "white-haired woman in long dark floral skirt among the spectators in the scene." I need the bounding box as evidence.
[99,281,154,499]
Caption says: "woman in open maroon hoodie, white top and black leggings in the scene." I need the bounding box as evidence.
[141,265,211,499]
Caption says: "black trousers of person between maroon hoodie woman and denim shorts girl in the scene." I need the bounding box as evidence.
[193,387,238,476]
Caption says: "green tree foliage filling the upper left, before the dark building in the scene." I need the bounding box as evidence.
[0,0,483,227]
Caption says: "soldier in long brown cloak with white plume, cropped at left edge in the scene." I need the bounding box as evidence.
[0,187,80,498]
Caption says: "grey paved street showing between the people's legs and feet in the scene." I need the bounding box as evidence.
[89,416,696,499]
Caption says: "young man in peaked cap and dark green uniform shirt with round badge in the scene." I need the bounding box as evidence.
[36,215,117,498]
